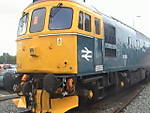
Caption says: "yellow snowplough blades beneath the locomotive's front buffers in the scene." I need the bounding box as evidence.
[13,90,79,113]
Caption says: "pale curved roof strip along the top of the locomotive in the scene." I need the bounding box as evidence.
[29,0,149,39]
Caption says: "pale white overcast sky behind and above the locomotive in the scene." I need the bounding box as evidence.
[0,0,150,55]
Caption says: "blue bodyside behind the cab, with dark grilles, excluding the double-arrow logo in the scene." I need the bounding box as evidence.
[104,17,150,71]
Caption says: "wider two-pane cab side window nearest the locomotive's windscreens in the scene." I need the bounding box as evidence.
[78,11,91,32]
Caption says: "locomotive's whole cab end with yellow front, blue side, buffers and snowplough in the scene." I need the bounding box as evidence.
[14,0,103,113]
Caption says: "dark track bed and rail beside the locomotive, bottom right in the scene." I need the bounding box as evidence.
[69,83,146,113]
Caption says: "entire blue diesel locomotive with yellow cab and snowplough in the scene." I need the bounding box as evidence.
[13,0,150,113]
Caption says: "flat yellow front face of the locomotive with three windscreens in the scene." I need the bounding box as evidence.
[17,2,77,74]
